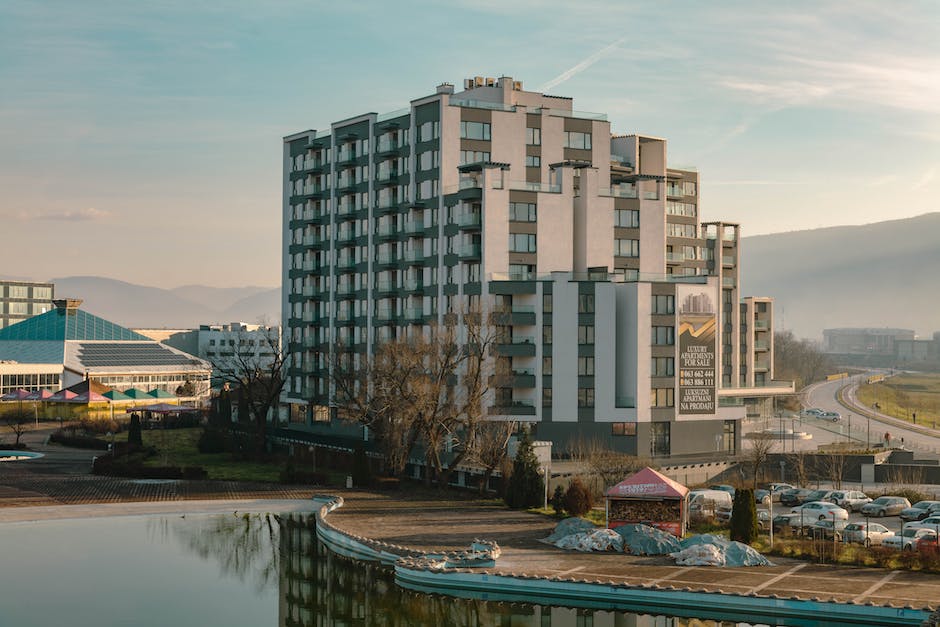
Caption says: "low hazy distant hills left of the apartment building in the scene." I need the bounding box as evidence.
[51,276,281,328]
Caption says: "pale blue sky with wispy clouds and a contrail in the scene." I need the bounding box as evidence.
[0,0,940,288]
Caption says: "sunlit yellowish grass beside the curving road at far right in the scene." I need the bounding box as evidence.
[858,373,940,428]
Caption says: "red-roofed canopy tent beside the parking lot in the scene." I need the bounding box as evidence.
[605,467,689,538]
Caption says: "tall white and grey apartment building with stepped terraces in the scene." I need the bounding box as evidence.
[283,77,792,460]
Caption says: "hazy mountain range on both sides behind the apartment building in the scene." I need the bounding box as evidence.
[5,213,940,339]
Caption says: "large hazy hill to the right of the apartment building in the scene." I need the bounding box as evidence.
[741,213,940,338]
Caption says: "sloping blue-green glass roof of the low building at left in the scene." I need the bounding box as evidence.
[0,308,151,342]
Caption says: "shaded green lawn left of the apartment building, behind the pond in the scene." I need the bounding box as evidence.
[108,427,283,482]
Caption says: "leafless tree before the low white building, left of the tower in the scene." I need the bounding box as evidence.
[210,325,289,455]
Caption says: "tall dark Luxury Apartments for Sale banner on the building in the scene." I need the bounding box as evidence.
[676,285,718,416]
